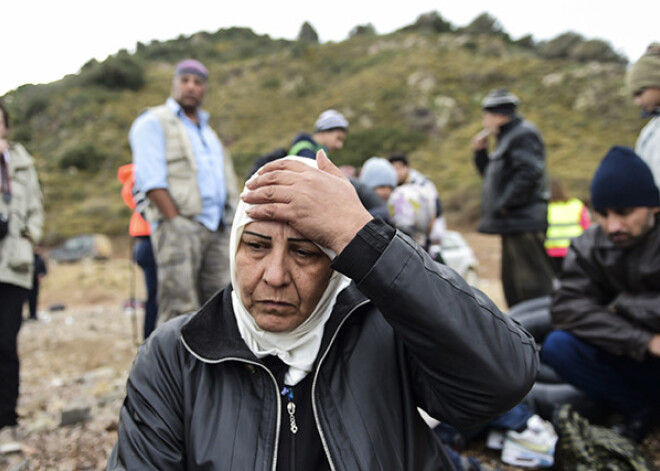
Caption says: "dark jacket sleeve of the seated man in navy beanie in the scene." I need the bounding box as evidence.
[550,244,657,360]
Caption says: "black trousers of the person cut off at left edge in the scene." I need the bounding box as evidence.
[0,283,29,427]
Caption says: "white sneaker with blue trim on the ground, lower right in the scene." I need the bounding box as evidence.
[502,415,557,468]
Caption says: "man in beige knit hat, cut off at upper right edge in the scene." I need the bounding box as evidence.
[626,43,660,187]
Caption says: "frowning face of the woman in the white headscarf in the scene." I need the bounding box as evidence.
[236,221,332,332]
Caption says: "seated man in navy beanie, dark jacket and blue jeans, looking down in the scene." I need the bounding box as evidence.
[541,147,660,441]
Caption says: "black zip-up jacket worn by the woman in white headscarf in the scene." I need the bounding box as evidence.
[108,224,538,471]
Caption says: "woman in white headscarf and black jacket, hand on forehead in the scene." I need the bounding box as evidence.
[108,152,538,470]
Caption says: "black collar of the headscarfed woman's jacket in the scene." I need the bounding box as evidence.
[181,284,367,363]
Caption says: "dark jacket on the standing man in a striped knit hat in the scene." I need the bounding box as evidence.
[475,116,549,234]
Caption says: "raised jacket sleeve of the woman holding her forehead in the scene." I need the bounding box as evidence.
[338,222,538,427]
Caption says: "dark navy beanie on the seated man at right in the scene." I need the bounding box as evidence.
[591,146,660,211]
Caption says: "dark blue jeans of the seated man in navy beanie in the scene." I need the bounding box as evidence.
[541,330,660,419]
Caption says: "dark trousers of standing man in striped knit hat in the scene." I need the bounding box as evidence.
[502,232,554,307]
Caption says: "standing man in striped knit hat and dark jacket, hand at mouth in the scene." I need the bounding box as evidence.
[473,89,553,307]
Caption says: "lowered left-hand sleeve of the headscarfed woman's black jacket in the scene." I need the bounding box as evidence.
[106,322,186,470]
